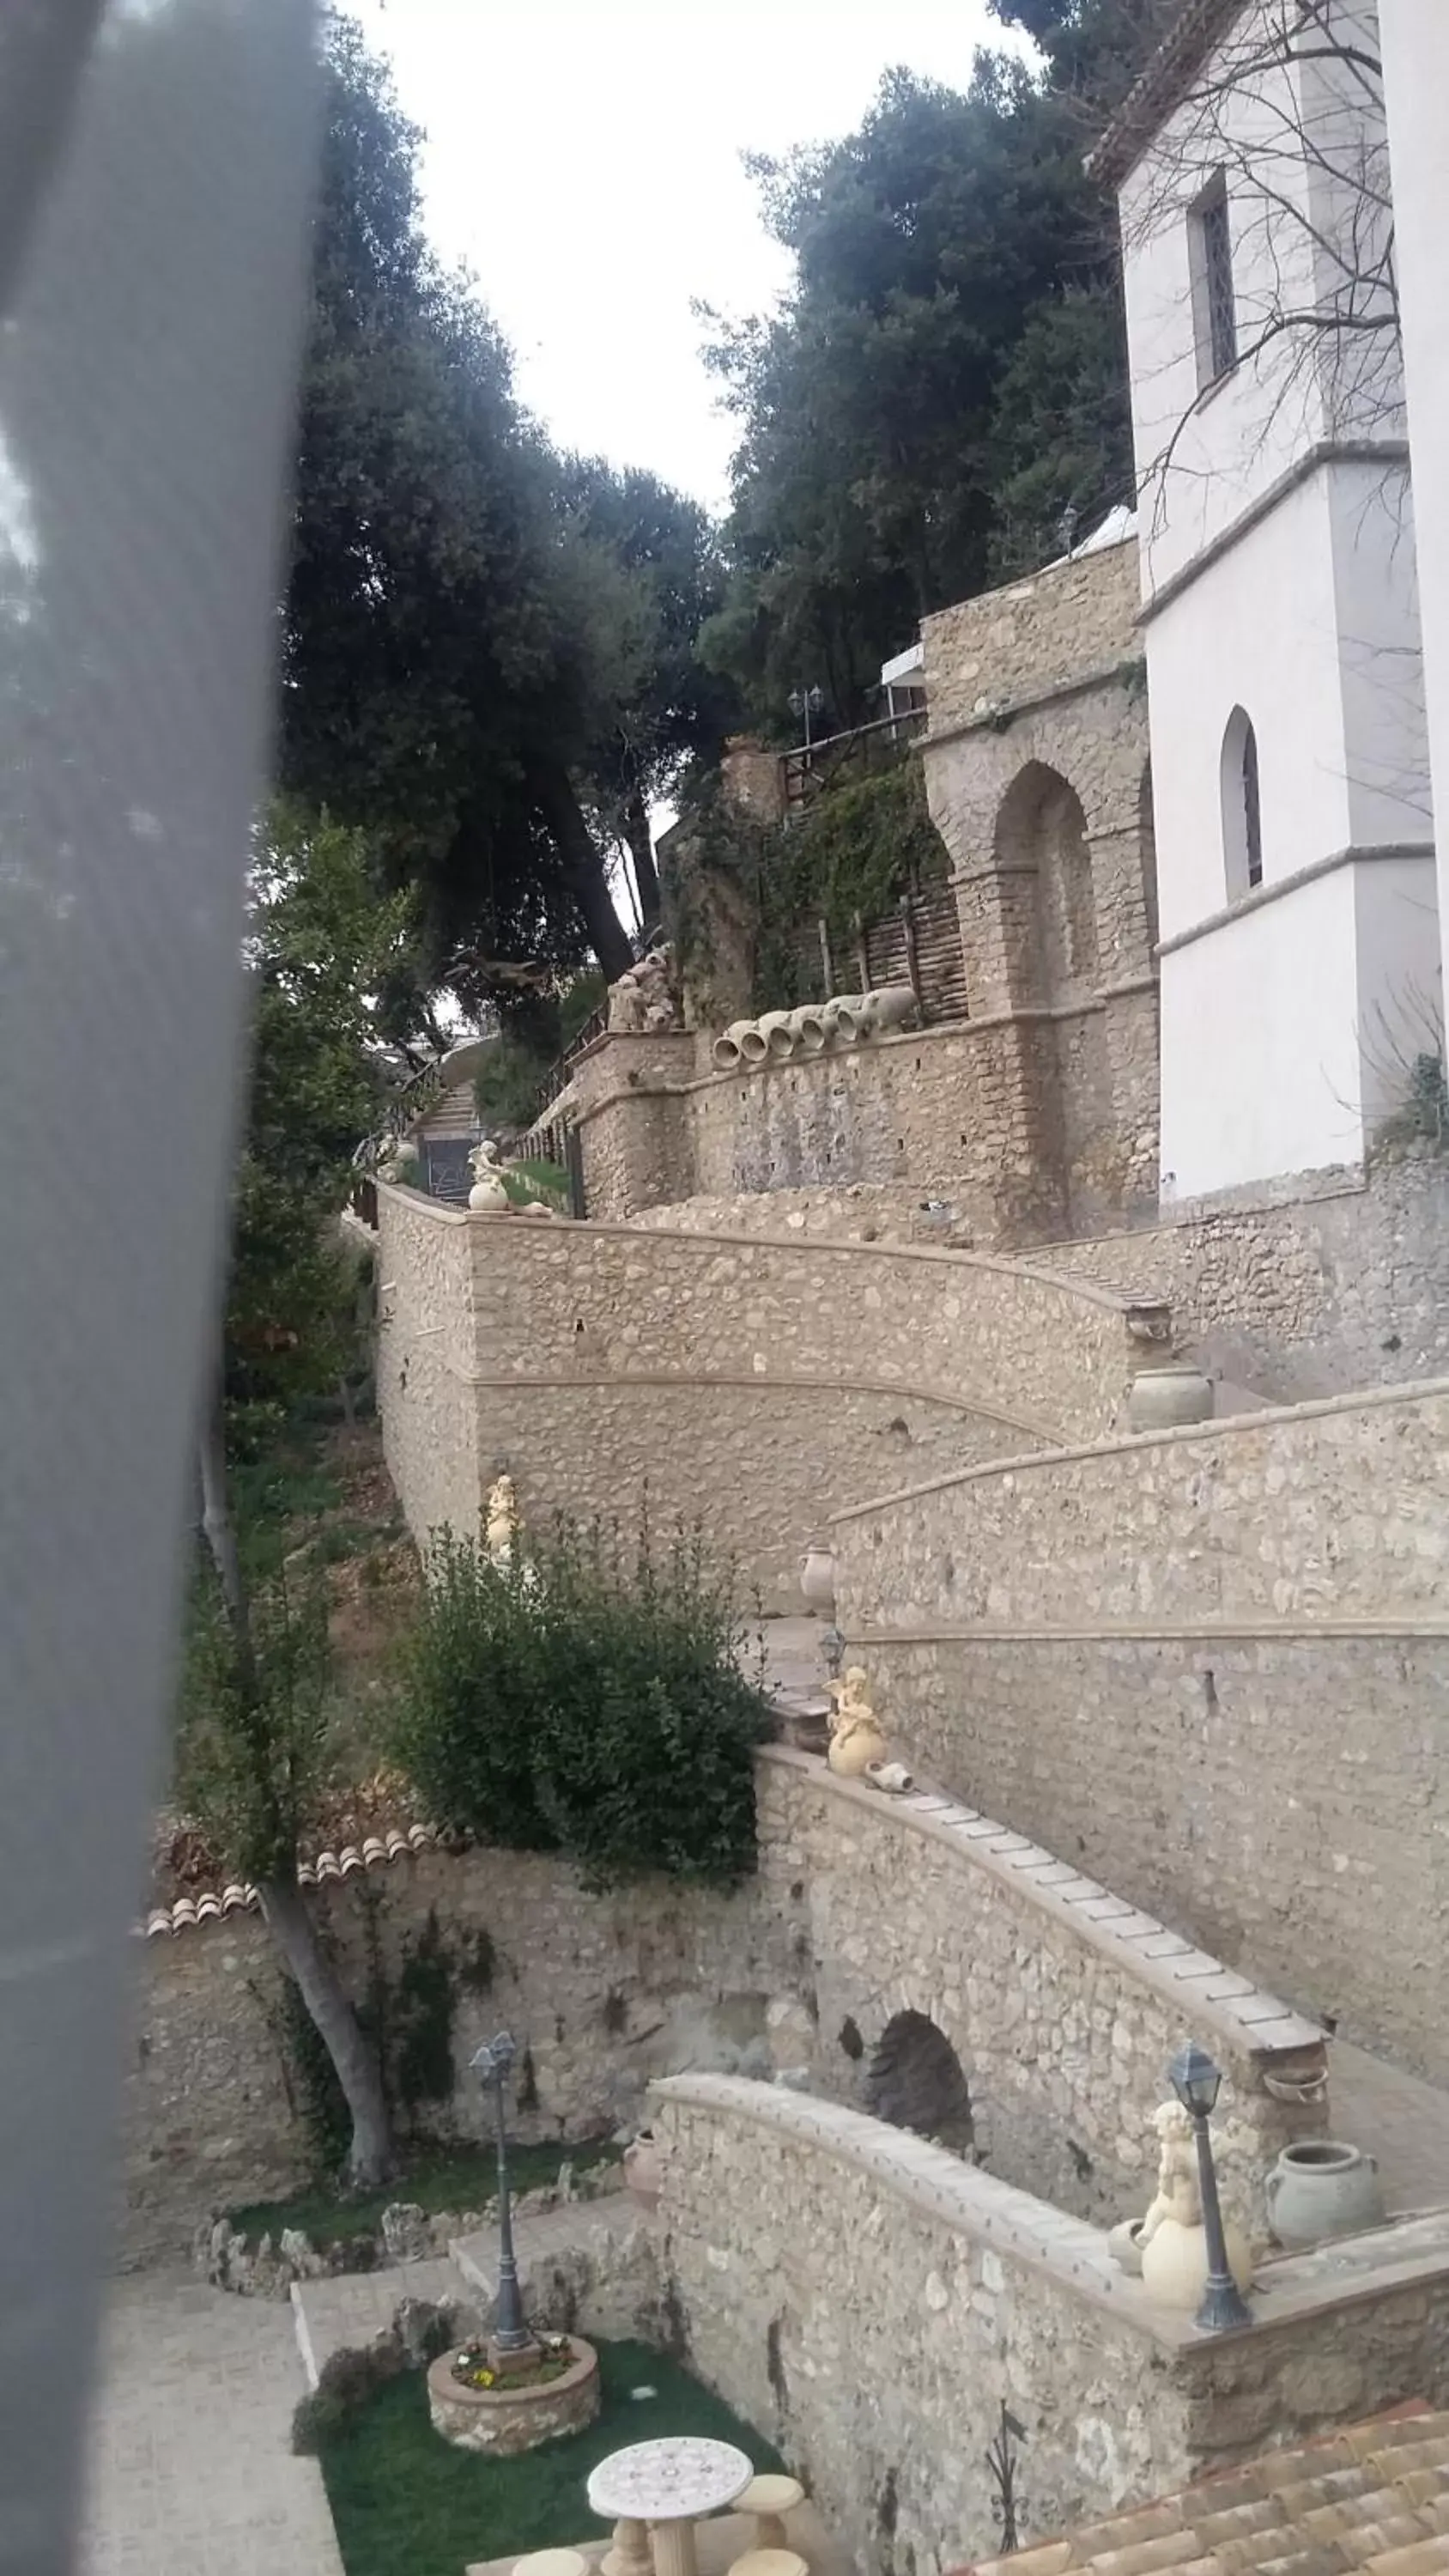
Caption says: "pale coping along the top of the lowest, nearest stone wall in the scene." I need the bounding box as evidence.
[649,2074,1449,2354]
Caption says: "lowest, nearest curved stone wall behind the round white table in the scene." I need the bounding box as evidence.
[654,2076,1449,2576]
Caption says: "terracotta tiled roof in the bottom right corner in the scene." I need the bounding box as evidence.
[957,2401,1449,2576]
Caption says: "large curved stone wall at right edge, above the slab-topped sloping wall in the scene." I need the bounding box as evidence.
[834,1381,1449,2079]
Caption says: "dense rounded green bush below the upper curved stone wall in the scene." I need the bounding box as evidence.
[385,1522,769,1886]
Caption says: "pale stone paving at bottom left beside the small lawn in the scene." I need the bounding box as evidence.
[77,2272,343,2576]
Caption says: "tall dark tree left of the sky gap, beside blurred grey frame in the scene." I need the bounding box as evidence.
[281,18,631,999]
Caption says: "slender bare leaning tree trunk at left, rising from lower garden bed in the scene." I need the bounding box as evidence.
[201,1396,394,2184]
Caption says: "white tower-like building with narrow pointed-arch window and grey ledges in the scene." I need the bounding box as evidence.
[1096,0,1449,1200]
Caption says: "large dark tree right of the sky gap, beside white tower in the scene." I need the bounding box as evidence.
[706,58,1148,734]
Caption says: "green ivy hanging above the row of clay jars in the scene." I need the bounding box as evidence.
[667,752,949,1010]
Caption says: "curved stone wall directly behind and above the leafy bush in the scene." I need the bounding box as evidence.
[379,1188,1155,1610]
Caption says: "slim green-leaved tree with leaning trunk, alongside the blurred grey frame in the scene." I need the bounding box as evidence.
[178,814,412,2182]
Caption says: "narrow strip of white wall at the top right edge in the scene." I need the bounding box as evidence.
[1379,0,1449,1025]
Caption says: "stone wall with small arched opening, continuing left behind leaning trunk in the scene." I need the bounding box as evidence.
[124,1747,1313,2259]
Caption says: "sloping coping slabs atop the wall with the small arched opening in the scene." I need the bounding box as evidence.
[759,1744,1323,2066]
